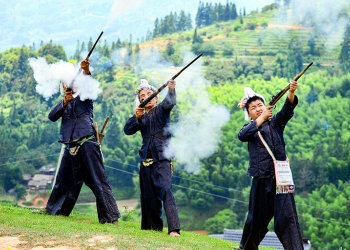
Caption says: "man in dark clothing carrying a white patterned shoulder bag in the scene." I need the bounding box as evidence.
[238,81,304,250]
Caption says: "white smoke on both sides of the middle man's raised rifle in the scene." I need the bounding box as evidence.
[110,48,230,173]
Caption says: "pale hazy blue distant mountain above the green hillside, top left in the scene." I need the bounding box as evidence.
[0,0,273,56]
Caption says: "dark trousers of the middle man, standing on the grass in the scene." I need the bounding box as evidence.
[140,160,180,233]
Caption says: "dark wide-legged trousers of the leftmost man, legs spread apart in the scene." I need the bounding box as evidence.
[46,141,120,223]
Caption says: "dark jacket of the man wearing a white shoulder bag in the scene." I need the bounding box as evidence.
[238,96,298,177]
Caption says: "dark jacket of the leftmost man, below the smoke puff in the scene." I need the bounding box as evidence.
[48,96,95,143]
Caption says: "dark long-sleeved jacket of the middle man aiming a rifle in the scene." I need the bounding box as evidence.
[124,89,176,162]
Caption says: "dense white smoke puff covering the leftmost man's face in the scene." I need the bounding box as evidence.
[28,57,102,101]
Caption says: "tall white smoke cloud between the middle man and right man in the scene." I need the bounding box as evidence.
[164,54,230,174]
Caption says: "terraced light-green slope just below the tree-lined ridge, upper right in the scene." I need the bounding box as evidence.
[140,10,342,70]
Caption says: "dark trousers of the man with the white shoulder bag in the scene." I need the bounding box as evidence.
[240,177,304,250]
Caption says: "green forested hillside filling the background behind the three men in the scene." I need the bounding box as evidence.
[0,2,350,249]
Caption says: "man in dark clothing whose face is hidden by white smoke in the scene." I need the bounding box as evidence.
[46,60,120,224]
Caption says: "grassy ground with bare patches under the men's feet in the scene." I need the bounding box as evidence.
[0,204,276,250]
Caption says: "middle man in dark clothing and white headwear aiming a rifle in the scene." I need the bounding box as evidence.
[124,79,180,236]
